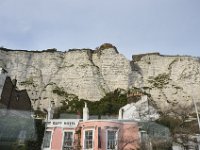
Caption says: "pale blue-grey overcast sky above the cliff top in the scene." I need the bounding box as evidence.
[0,0,200,59]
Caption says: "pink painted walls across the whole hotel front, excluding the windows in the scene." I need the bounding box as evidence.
[45,120,139,150]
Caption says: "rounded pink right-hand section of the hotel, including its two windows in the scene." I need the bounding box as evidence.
[78,120,139,150]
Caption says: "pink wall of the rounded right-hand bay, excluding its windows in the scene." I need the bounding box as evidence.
[79,120,139,150]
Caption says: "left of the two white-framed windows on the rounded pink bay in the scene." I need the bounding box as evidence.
[84,130,93,149]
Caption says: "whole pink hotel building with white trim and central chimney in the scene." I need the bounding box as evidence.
[42,103,140,150]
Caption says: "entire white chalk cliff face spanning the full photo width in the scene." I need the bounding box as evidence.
[0,48,200,109]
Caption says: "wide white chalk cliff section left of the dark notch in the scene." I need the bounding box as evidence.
[0,48,131,108]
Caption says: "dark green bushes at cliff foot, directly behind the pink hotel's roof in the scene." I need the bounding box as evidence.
[54,87,128,118]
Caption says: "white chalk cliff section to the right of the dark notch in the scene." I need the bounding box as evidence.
[133,54,200,110]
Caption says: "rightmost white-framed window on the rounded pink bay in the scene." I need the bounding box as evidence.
[107,130,117,150]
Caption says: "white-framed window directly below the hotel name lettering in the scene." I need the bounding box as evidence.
[63,132,73,150]
